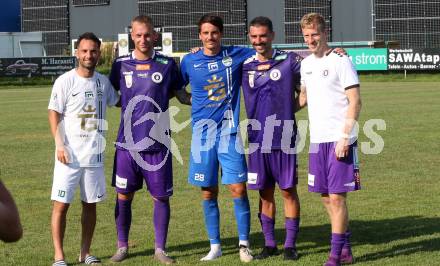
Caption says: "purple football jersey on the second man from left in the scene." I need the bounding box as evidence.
[110,53,182,151]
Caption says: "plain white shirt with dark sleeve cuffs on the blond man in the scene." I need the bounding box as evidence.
[301,52,359,143]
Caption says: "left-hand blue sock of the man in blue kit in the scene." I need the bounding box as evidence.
[203,199,220,244]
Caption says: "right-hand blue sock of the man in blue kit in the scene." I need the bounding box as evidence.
[234,196,251,241]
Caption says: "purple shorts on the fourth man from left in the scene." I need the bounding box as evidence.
[248,150,298,190]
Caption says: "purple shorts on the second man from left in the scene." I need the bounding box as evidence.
[112,149,173,198]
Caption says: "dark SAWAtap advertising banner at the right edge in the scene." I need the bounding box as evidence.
[388,48,440,70]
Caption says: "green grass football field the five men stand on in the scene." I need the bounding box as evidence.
[0,82,440,265]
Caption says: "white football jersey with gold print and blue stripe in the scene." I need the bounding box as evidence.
[48,69,119,167]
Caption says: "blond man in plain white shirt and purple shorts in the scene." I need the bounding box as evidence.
[300,13,361,266]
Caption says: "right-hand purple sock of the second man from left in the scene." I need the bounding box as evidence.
[153,199,170,250]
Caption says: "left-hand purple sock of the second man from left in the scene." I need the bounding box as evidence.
[115,196,132,248]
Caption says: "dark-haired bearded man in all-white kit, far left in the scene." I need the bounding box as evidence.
[48,32,119,266]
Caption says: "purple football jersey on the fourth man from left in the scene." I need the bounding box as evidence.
[242,50,302,150]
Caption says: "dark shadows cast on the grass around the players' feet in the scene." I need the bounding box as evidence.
[99,216,440,262]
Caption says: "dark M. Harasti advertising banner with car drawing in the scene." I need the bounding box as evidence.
[0,57,75,77]
